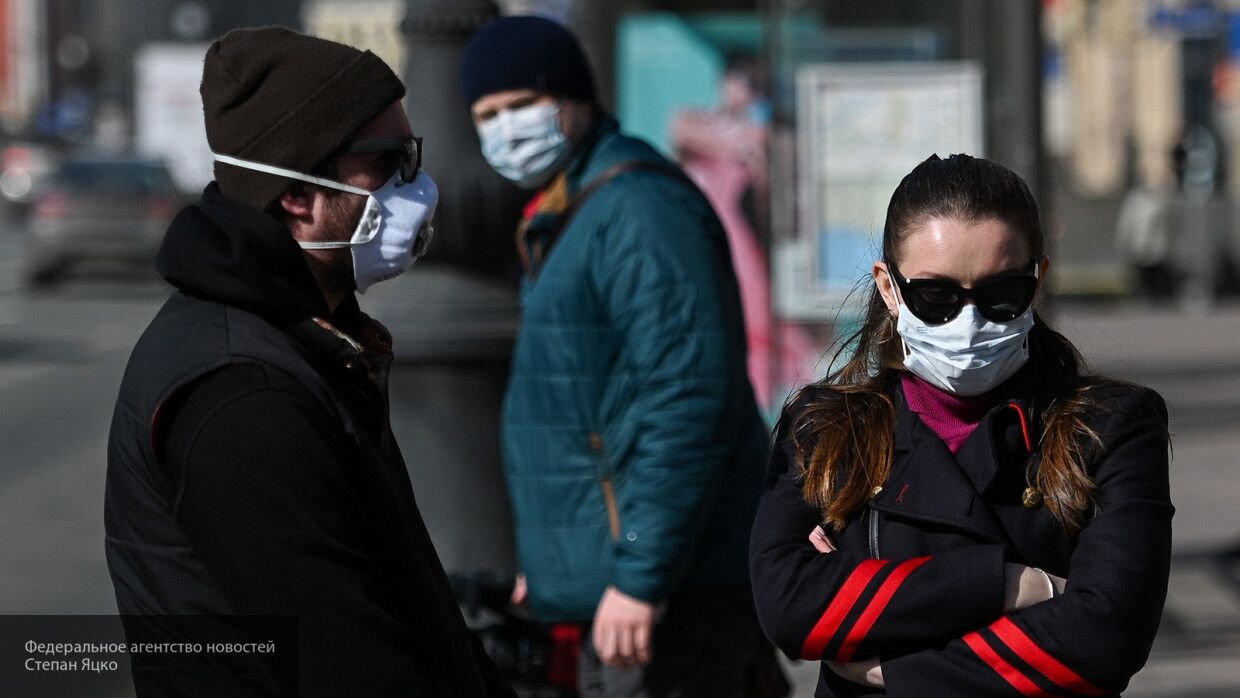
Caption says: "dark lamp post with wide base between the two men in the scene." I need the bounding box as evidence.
[391,0,523,579]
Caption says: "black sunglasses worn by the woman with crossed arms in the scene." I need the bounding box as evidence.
[887,258,1042,325]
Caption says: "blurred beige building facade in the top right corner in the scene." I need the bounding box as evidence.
[1044,0,1240,196]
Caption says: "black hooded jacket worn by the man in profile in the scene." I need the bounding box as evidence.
[104,185,512,697]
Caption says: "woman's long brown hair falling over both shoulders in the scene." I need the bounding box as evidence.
[792,155,1107,533]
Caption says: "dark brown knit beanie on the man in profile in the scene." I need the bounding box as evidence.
[198,27,404,208]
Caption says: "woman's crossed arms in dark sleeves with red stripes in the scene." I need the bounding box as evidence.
[750,389,1173,696]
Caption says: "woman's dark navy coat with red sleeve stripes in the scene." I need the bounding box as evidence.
[750,371,1174,697]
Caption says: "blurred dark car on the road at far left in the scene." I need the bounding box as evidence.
[26,157,184,286]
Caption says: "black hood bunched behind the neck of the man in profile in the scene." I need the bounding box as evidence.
[155,182,327,317]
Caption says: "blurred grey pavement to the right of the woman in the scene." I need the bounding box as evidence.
[1063,305,1240,698]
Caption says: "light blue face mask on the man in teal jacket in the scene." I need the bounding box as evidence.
[477,104,569,188]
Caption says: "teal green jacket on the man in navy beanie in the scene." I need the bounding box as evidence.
[503,118,769,621]
